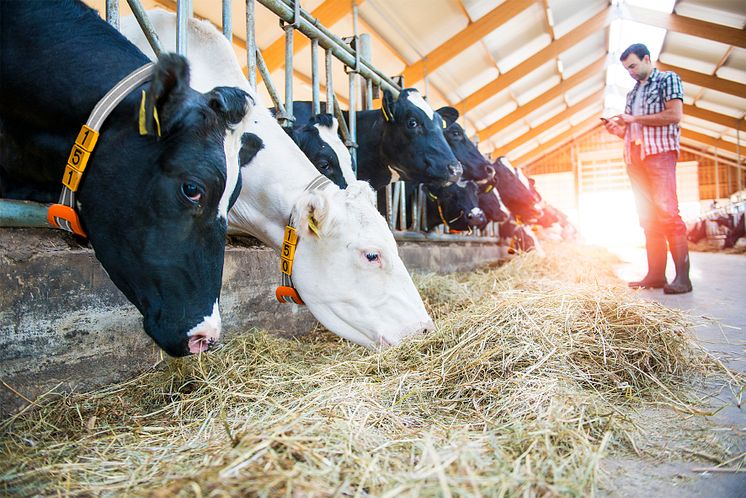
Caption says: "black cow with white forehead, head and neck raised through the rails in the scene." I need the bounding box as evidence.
[293,88,462,190]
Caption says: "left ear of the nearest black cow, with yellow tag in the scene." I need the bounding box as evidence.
[139,53,189,136]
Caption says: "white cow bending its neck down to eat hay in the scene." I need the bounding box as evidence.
[121,10,433,347]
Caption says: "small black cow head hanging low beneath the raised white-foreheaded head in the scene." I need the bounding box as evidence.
[425,180,487,231]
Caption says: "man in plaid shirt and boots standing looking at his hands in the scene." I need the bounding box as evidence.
[604,43,692,294]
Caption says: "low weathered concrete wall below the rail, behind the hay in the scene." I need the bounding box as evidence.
[0,229,499,415]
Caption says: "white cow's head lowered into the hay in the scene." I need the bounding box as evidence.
[292,181,433,347]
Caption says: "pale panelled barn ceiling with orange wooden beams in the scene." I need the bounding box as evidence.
[86,0,746,165]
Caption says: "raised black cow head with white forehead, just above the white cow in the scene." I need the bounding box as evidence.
[381,88,463,186]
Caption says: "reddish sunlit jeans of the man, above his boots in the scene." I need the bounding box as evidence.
[627,145,686,237]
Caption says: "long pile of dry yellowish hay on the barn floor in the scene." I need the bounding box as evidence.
[0,241,736,497]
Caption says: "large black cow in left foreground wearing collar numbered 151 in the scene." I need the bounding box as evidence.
[0,0,248,356]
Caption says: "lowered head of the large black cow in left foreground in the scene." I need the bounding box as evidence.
[79,54,247,356]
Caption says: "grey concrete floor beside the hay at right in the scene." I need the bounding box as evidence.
[601,248,746,498]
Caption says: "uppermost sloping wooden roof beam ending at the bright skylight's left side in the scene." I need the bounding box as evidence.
[454,7,613,114]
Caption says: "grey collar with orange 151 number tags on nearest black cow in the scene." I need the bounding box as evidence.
[47,62,155,237]
